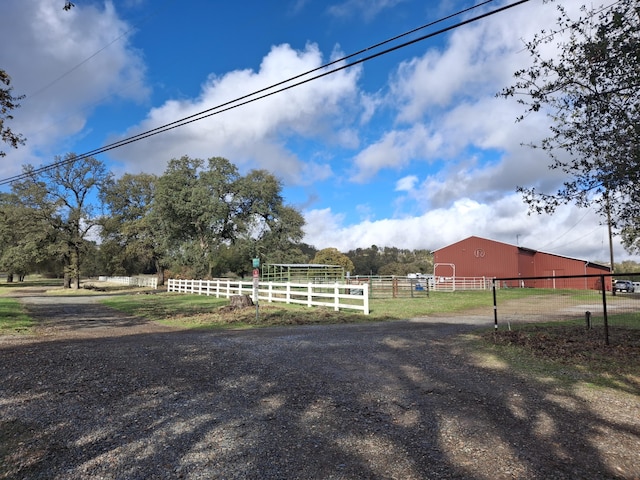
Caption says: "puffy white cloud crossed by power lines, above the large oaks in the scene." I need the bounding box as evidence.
[109,44,359,184]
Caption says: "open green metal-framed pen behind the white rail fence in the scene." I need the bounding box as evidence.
[260,263,345,283]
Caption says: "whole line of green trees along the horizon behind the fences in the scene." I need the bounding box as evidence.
[0,154,639,288]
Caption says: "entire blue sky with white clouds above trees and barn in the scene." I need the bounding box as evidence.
[0,0,639,261]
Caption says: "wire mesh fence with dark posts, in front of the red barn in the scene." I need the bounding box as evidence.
[493,273,640,345]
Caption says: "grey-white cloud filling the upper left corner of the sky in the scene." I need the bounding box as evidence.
[0,0,149,177]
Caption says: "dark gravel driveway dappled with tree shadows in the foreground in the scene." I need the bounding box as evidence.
[0,296,640,480]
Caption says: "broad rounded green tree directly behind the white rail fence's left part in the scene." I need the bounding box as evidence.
[151,156,304,278]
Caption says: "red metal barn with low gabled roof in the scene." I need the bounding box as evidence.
[433,237,611,290]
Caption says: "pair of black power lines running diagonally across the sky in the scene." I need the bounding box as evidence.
[0,0,529,185]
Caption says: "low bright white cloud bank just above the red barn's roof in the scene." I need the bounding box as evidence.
[304,194,628,262]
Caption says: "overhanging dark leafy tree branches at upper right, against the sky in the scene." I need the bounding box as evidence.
[500,0,640,248]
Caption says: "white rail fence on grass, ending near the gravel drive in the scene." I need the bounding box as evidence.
[167,278,369,315]
